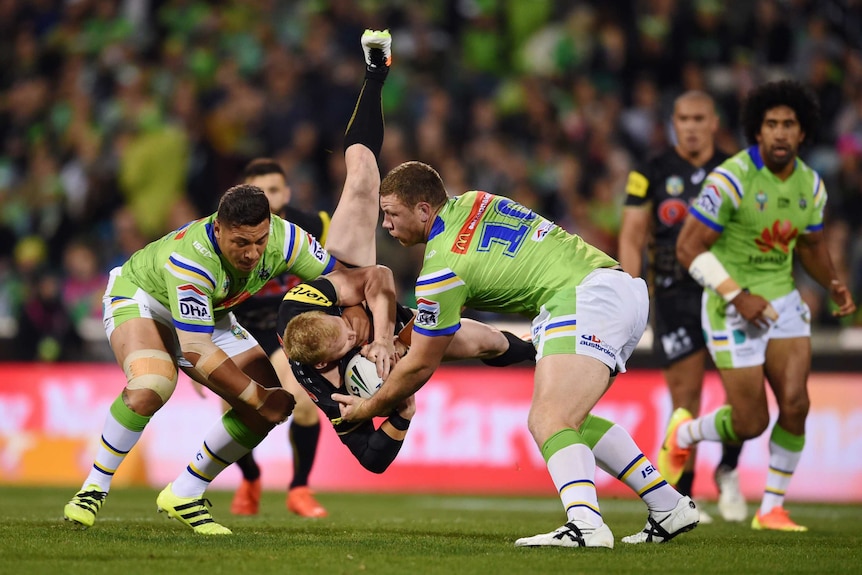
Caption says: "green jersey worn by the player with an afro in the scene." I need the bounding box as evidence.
[690,146,826,301]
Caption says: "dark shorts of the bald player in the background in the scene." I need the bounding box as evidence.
[653,287,706,367]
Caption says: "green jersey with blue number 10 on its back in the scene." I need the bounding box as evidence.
[413,191,617,336]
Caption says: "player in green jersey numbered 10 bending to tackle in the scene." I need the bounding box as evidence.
[332,162,698,548]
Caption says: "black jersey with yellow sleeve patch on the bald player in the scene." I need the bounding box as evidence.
[625,148,729,291]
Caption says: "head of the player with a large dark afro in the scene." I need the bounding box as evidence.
[742,80,820,171]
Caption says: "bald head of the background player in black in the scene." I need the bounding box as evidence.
[672,90,718,160]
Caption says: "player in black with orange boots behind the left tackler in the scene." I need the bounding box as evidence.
[230,158,330,517]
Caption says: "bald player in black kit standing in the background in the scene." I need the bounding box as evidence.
[619,91,746,523]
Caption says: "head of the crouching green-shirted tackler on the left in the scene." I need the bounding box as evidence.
[213,184,270,271]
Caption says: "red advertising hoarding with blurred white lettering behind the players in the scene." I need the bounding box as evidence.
[0,364,862,502]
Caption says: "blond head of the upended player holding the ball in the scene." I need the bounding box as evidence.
[282,311,357,366]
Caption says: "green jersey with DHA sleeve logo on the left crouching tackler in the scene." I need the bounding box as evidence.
[117,214,336,333]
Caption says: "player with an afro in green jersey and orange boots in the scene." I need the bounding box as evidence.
[658,80,856,531]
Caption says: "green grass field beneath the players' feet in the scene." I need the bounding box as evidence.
[0,487,862,575]
